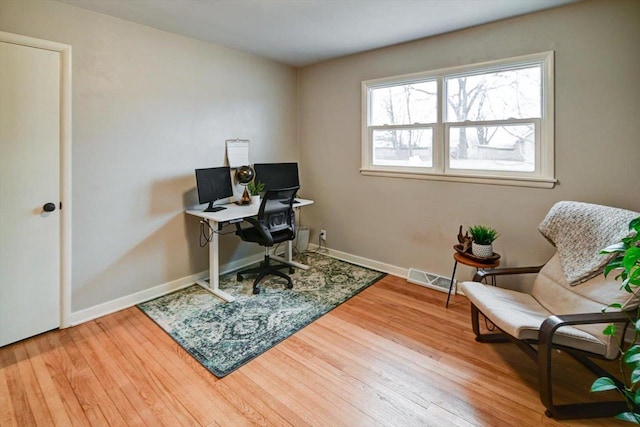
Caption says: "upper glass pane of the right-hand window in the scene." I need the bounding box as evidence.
[445,65,542,122]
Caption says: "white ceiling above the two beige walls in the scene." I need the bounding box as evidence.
[59,0,579,66]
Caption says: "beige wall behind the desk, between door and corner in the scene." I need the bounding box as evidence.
[0,0,298,311]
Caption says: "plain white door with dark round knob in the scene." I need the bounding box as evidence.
[0,42,61,346]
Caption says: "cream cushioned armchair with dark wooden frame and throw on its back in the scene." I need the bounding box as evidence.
[461,202,638,419]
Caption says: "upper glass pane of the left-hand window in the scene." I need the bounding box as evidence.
[369,81,438,126]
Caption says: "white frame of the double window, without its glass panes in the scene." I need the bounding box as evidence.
[360,51,556,188]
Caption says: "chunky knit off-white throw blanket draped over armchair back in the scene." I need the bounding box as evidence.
[538,202,640,286]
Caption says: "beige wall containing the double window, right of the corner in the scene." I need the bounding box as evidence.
[299,0,640,279]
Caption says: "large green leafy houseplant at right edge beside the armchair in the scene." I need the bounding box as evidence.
[591,217,640,424]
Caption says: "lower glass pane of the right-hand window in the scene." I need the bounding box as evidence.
[449,123,535,172]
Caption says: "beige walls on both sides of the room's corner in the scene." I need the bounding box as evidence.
[0,0,640,311]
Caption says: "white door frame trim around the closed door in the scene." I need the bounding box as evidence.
[0,31,72,328]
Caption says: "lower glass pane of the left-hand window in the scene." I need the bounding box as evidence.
[373,128,433,167]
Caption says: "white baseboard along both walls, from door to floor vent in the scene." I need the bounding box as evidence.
[69,244,409,326]
